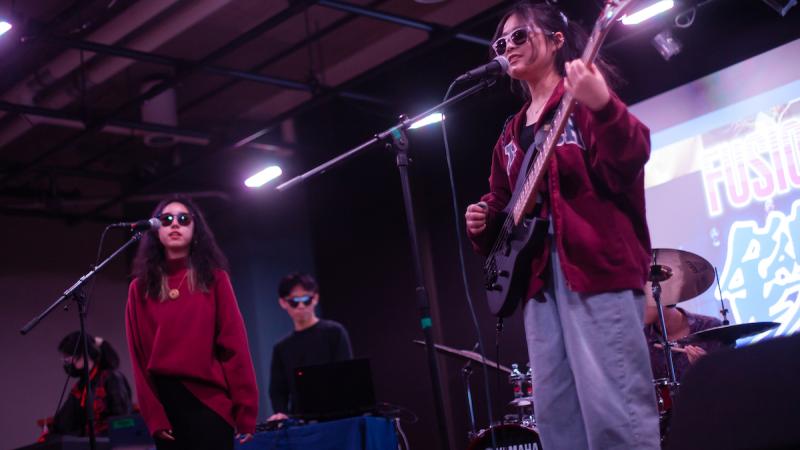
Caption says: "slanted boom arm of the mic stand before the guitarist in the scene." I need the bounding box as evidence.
[276,79,496,191]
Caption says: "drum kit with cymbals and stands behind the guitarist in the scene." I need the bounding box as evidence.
[414,249,780,450]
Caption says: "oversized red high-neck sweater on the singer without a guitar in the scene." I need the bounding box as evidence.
[125,259,258,433]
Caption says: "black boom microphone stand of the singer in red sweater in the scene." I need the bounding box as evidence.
[19,233,142,450]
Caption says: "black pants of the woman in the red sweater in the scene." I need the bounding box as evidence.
[153,376,233,450]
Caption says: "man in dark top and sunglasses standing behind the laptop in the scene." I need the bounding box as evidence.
[267,273,353,421]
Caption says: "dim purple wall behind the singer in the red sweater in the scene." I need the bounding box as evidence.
[0,185,313,449]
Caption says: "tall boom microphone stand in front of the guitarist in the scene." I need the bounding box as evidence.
[277,79,495,450]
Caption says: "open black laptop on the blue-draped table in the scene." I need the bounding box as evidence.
[293,359,375,420]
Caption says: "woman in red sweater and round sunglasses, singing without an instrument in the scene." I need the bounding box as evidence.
[125,197,258,450]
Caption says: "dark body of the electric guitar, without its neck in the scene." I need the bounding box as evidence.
[485,207,550,317]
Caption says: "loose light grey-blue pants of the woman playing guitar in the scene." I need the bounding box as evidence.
[524,245,660,450]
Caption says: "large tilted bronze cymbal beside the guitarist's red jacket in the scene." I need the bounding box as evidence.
[644,248,714,306]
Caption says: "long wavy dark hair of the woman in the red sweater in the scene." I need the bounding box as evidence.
[133,194,228,300]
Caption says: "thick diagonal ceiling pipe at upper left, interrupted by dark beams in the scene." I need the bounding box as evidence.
[0,0,231,147]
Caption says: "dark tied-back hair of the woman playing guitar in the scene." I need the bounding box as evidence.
[490,0,622,99]
